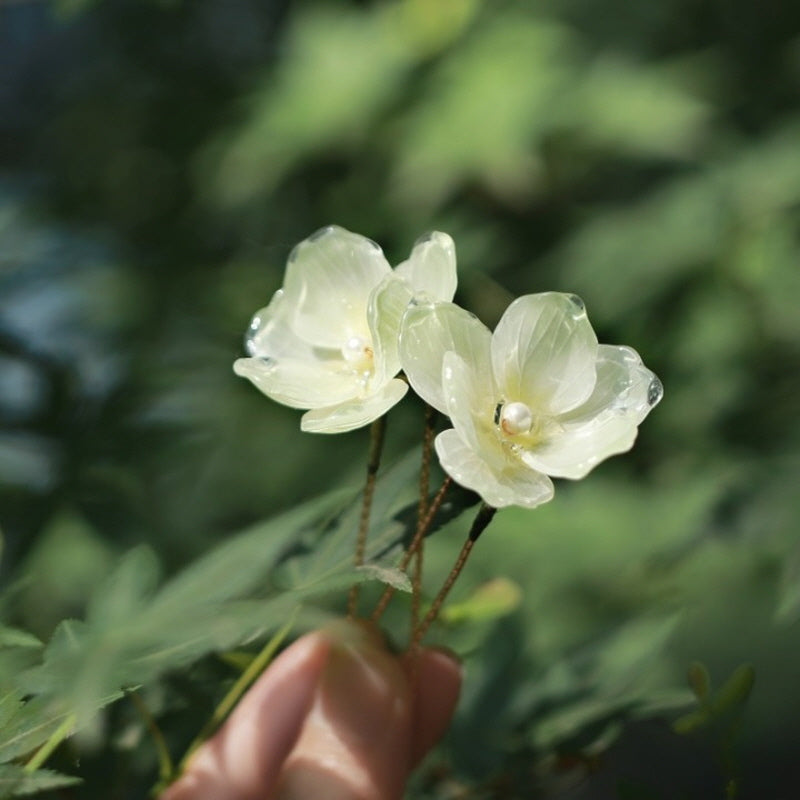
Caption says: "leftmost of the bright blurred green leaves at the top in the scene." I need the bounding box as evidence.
[217,6,416,203]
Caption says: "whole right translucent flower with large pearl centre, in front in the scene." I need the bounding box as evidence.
[400,292,663,508]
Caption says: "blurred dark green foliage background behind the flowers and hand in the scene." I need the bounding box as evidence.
[0,0,800,799]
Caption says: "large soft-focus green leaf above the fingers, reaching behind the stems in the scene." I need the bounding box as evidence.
[7,452,476,746]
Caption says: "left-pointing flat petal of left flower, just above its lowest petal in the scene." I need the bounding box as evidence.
[233,358,358,408]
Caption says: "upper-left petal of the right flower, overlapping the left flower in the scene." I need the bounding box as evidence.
[400,303,492,414]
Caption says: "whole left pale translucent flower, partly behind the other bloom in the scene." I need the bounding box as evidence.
[233,226,456,433]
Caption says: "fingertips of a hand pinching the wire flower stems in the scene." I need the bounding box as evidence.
[161,622,461,800]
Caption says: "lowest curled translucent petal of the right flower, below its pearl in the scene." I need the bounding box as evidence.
[435,428,553,508]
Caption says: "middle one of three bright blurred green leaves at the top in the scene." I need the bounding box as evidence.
[390,14,576,209]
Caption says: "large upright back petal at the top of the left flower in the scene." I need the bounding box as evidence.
[284,225,391,349]
